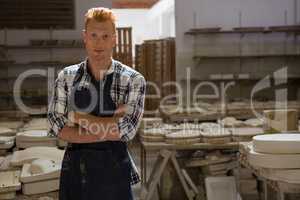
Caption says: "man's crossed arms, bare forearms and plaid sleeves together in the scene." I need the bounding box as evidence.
[48,71,146,143]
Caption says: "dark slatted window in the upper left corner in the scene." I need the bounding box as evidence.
[0,0,75,29]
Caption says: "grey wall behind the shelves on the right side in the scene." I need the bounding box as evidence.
[175,0,300,101]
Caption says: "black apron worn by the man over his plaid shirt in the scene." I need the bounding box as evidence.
[59,73,133,200]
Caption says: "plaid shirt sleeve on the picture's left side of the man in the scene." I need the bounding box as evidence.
[47,71,68,137]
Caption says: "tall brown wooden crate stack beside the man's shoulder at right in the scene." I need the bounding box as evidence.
[135,38,176,115]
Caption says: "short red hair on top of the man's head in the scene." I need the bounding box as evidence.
[84,7,116,30]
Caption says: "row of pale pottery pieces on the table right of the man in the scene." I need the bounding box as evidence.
[139,117,264,145]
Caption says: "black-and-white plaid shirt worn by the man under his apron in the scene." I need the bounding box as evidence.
[48,60,146,185]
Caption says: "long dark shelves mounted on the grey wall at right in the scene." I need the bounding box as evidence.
[185,26,300,81]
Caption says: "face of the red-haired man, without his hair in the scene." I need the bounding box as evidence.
[83,19,116,62]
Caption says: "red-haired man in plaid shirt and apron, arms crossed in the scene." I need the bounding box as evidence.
[48,8,146,200]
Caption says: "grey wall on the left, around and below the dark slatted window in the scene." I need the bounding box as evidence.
[0,0,112,110]
